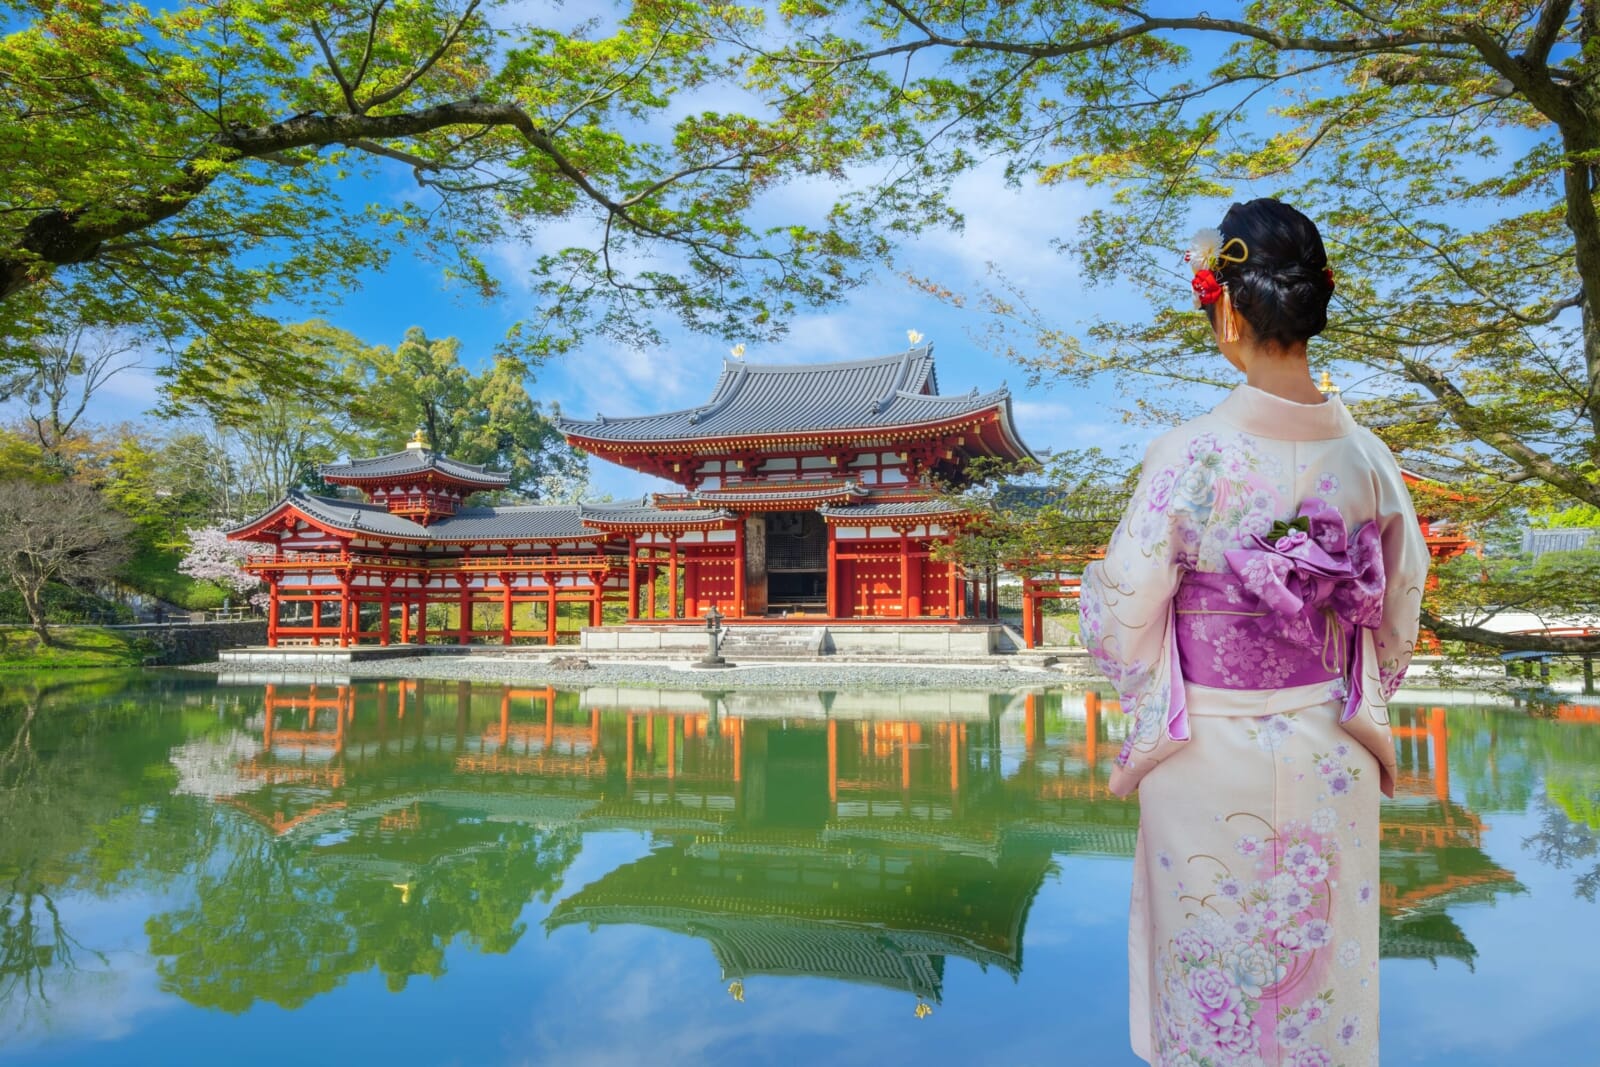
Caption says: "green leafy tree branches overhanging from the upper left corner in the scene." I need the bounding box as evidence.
[0,0,891,412]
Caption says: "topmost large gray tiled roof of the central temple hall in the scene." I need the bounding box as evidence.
[557,346,1011,442]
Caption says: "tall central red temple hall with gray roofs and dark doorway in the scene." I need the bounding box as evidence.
[560,346,1030,622]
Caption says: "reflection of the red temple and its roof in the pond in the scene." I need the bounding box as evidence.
[190,681,1522,1005]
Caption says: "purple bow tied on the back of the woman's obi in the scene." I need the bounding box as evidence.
[1224,498,1384,721]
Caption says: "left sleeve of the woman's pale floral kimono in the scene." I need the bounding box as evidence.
[1078,434,1197,769]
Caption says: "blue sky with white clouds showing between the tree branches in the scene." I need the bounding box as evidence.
[34,0,1376,498]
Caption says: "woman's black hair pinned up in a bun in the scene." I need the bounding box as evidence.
[1206,197,1333,349]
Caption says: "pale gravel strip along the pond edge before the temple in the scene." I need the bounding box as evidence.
[186,656,1093,693]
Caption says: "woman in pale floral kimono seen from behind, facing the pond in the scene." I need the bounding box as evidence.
[1080,200,1429,1067]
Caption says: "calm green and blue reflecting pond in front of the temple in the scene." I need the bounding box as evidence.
[0,675,1600,1067]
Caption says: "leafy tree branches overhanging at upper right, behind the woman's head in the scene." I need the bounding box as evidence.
[752,0,1600,646]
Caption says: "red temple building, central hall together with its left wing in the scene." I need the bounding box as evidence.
[229,346,1032,646]
